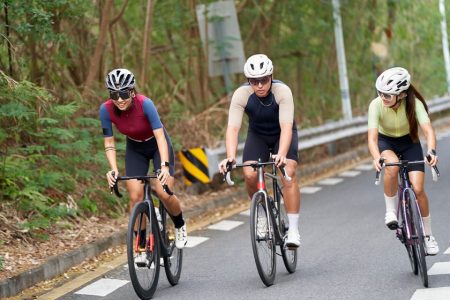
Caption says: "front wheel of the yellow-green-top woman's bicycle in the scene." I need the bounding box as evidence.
[408,190,428,287]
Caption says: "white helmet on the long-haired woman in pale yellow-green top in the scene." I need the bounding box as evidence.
[375,67,411,95]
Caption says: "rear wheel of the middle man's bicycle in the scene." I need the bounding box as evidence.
[277,191,297,274]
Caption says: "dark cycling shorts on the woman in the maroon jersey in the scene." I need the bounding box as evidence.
[125,129,175,176]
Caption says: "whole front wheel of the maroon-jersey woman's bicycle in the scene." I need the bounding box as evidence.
[127,202,160,299]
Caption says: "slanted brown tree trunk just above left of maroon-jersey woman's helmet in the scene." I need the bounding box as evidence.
[82,0,113,97]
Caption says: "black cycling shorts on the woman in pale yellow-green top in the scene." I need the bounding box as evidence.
[378,133,425,172]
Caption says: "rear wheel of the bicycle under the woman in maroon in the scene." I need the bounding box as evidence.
[159,203,183,286]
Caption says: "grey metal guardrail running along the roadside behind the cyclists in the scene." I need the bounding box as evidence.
[206,96,450,177]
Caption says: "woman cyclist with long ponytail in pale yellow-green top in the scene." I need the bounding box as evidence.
[368,67,439,255]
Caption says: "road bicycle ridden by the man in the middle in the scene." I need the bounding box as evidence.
[225,159,297,286]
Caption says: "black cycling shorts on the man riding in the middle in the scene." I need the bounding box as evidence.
[242,130,298,162]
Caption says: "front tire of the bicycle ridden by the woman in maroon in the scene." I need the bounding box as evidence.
[127,202,160,299]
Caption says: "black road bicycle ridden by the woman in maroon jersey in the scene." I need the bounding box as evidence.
[111,175,183,299]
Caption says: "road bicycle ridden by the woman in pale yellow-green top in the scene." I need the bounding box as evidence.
[375,156,440,287]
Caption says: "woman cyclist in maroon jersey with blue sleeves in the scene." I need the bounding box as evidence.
[100,69,187,249]
